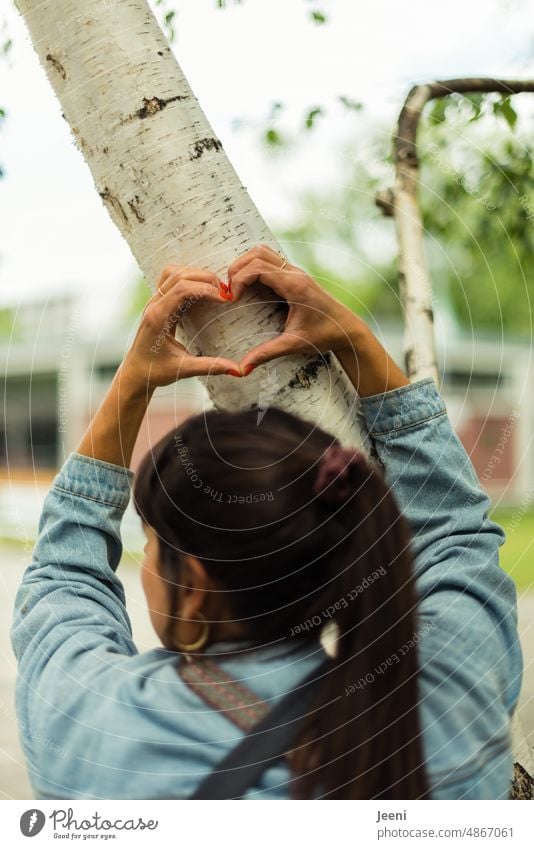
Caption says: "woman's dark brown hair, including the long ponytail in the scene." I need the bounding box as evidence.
[134,407,427,799]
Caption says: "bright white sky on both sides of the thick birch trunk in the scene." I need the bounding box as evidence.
[0,0,534,328]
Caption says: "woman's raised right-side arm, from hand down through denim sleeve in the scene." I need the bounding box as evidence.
[231,247,522,712]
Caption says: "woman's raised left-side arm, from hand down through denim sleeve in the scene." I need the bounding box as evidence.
[11,267,241,776]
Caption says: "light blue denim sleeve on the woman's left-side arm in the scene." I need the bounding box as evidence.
[11,454,137,756]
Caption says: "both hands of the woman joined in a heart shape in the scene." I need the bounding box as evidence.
[122,245,363,389]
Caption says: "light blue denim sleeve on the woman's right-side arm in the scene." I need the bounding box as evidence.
[362,378,522,714]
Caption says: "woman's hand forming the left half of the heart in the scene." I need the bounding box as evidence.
[121,265,240,392]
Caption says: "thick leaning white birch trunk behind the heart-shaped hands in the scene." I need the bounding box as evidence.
[18,0,368,445]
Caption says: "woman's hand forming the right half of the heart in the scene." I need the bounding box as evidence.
[228,240,370,374]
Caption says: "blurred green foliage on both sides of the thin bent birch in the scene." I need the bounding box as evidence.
[281,107,534,335]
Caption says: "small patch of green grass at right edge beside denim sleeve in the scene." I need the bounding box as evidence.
[491,507,534,592]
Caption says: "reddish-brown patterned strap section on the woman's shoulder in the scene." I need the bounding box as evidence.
[178,658,270,731]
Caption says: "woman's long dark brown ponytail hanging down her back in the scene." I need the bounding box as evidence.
[292,443,427,799]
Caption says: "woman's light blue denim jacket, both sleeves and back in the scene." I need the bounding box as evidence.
[12,379,522,799]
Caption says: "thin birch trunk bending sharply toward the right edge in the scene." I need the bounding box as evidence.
[377,77,534,799]
